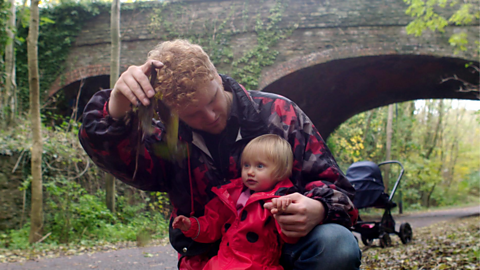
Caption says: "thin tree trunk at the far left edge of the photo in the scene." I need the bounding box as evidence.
[3,0,17,123]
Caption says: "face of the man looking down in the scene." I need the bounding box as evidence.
[178,75,232,134]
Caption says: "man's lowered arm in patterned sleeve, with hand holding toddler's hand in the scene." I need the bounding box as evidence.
[265,99,357,237]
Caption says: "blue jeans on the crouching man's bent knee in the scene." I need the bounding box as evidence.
[280,223,362,270]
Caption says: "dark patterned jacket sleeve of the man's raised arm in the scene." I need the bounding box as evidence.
[78,90,171,191]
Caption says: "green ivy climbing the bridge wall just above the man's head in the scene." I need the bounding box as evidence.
[150,0,294,89]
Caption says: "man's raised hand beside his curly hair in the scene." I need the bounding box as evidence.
[108,60,163,118]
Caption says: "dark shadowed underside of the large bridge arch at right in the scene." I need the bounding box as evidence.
[262,54,480,139]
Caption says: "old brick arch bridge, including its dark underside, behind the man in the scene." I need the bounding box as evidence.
[50,0,479,138]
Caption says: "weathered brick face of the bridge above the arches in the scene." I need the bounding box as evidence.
[50,0,479,93]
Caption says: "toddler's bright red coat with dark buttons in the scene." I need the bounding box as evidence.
[185,178,298,270]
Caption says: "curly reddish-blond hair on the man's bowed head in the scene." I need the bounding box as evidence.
[148,39,218,109]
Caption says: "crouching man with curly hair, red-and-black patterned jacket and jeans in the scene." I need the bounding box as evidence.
[79,40,361,269]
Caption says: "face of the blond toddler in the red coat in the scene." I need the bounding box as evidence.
[242,155,278,192]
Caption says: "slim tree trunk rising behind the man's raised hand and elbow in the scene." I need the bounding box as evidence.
[105,0,120,213]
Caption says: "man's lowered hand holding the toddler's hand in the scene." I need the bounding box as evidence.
[264,193,325,237]
